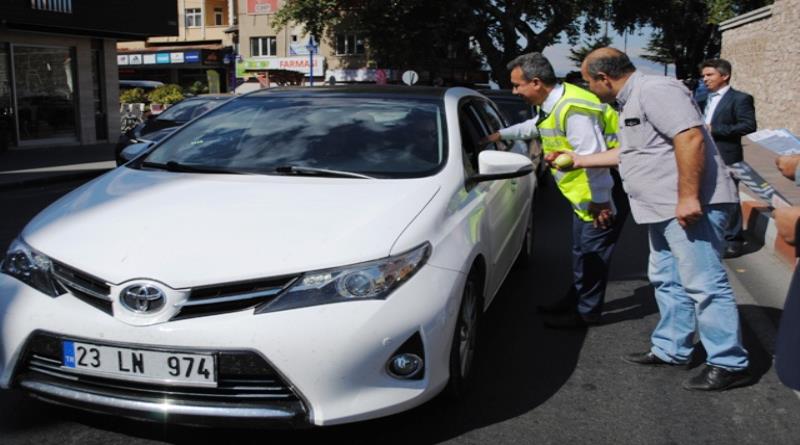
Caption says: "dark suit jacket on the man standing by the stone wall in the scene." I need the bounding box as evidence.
[698,88,756,165]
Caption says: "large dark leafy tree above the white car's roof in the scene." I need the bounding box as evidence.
[277,0,607,87]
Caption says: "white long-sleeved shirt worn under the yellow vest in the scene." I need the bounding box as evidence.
[499,83,614,203]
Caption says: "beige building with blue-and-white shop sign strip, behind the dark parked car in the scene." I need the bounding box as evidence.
[117,0,236,93]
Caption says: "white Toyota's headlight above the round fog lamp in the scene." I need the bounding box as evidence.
[256,242,431,313]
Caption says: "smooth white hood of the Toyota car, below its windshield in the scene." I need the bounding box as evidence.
[22,167,439,288]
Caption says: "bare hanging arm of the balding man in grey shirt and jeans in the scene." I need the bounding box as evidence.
[672,127,705,227]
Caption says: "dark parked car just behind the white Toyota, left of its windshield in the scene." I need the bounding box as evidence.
[114,94,231,165]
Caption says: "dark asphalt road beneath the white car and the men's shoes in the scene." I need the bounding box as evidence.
[0,175,800,445]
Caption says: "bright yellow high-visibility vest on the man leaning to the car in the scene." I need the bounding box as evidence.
[536,83,619,221]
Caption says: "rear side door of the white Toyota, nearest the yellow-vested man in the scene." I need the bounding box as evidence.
[476,100,533,284]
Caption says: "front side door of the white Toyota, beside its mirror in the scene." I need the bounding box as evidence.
[459,100,514,305]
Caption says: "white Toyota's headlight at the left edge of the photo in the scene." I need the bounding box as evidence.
[0,238,66,297]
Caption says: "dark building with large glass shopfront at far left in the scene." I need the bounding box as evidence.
[0,0,177,150]
